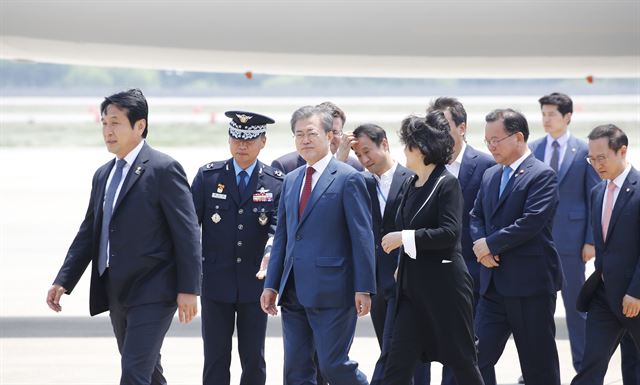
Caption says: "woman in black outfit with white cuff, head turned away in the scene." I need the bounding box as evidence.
[382,111,484,385]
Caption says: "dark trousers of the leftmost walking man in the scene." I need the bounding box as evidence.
[103,273,177,385]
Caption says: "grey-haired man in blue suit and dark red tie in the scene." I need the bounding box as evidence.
[260,106,376,385]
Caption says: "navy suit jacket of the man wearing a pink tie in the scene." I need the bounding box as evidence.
[591,167,640,316]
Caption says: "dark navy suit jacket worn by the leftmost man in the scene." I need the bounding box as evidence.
[54,143,202,315]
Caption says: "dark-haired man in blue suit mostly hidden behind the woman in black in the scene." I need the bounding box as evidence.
[427,97,496,385]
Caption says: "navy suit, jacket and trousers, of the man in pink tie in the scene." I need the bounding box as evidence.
[571,167,640,385]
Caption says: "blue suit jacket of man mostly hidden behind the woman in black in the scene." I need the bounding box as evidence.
[458,145,496,288]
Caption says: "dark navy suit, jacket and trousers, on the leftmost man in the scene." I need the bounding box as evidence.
[54,143,201,385]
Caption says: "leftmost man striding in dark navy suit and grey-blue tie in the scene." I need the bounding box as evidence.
[47,89,202,385]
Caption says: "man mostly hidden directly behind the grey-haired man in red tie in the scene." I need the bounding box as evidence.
[271,102,364,174]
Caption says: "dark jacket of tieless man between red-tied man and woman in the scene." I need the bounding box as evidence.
[365,164,414,298]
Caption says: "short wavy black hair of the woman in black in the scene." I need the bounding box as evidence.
[399,111,454,165]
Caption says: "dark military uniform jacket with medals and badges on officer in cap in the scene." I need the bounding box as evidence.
[192,159,284,303]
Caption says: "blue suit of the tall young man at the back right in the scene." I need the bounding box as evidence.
[529,135,600,371]
